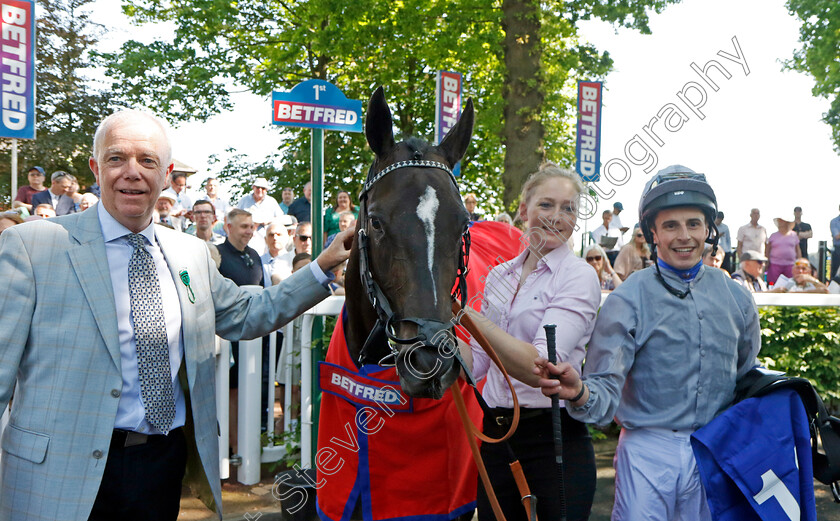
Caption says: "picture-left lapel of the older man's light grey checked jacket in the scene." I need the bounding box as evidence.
[67,207,120,371]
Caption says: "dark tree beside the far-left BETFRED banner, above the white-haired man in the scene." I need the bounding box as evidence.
[0,0,110,204]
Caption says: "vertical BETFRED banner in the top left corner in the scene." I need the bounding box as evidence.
[0,0,35,139]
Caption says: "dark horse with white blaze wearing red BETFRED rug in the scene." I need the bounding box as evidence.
[315,87,480,521]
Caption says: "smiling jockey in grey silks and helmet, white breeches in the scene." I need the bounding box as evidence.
[535,165,761,521]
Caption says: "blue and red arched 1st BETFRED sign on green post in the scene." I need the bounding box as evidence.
[271,80,362,132]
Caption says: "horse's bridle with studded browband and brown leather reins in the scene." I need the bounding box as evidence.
[357,157,537,521]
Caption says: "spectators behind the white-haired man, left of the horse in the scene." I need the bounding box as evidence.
[0,166,352,294]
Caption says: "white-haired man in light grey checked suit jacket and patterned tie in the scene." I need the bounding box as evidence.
[0,107,352,521]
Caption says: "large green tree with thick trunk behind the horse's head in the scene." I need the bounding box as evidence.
[103,0,666,211]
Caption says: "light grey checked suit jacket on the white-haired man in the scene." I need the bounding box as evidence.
[0,207,329,521]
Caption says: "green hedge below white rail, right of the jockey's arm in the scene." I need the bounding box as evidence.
[759,306,840,411]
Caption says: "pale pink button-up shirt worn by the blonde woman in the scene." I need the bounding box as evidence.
[471,246,601,408]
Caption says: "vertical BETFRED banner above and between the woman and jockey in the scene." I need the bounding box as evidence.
[575,81,603,182]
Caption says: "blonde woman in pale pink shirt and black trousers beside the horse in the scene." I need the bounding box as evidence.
[462,163,601,521]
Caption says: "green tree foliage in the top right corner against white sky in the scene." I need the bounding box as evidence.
[785,0,840,154]
